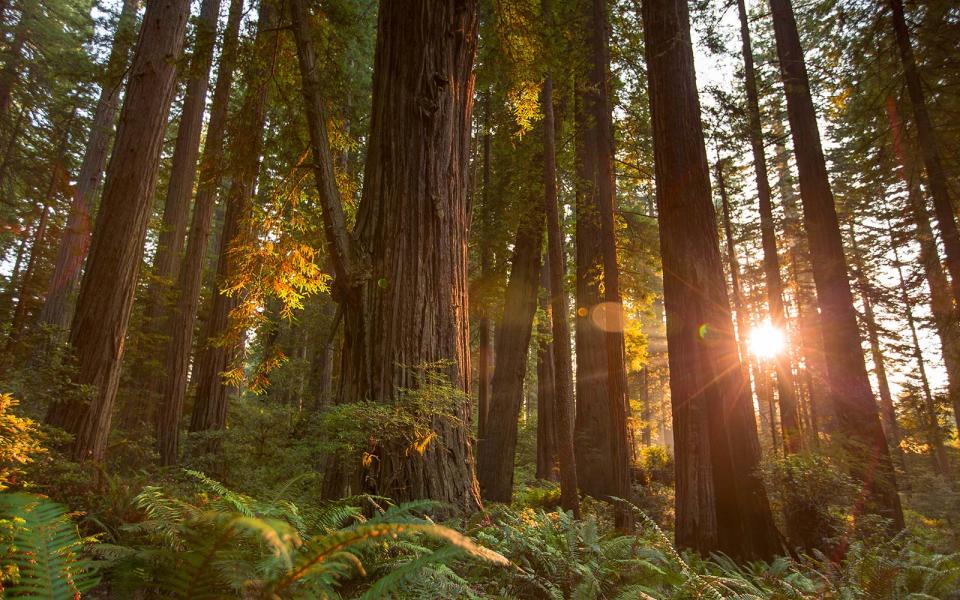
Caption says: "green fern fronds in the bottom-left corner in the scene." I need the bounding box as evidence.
[0,493,98,600]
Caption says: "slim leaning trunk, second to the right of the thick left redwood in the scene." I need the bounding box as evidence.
[157,0,246,465]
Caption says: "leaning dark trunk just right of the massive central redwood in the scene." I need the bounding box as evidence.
[477,186,544,502]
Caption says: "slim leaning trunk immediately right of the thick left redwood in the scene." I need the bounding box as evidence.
[121,0,220,430]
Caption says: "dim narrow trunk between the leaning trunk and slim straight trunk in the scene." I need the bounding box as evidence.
[537,260,558,481]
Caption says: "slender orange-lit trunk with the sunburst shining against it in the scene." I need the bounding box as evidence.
[737,0,803,453]
